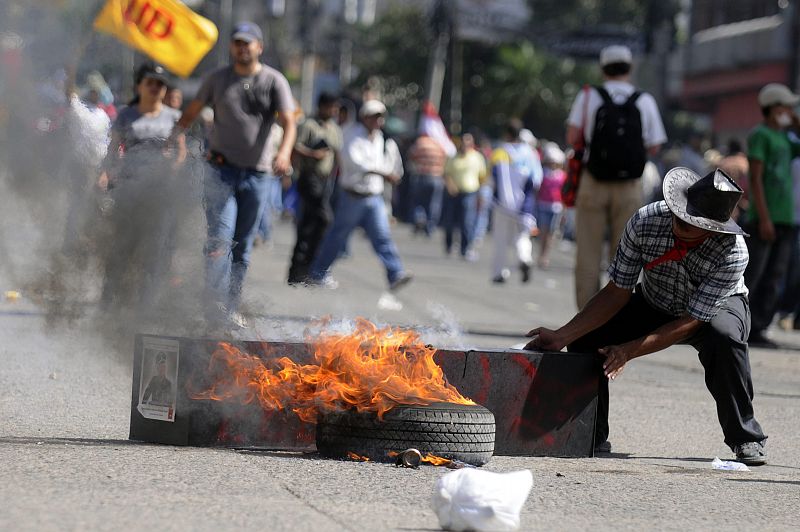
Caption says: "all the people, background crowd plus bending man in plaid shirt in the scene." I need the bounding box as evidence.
[9,13,800,464]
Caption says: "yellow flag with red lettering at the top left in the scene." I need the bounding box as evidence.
[94,0,219,78]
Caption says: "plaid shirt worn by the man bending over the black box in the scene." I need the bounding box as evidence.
[608,201,748,322]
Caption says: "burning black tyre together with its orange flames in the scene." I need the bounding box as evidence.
[190,319,495,465]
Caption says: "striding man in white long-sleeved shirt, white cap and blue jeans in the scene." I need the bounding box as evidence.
[309,100,411,290]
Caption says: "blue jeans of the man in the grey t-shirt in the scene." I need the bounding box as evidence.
[204,164,269,310]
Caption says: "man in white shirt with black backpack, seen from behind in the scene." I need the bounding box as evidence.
[567,46,667,308]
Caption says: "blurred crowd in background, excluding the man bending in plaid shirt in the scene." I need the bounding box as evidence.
[14,22,800,345]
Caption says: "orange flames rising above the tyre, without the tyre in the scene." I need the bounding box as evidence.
[192,318,475,423]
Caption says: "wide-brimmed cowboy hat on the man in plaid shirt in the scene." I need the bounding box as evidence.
[663,167,749,236]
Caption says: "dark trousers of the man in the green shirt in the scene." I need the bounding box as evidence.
[744,224,797,333]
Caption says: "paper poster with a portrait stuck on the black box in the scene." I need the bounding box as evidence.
[136,336,180,422]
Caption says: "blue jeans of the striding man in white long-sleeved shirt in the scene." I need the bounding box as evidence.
[309,190,403,284]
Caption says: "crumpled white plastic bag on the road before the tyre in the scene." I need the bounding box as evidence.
[432,469,533,532]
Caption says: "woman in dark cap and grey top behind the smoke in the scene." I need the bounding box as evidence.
[98,64,192,316]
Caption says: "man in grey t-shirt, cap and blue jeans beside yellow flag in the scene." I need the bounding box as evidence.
[176,22,297,327]
